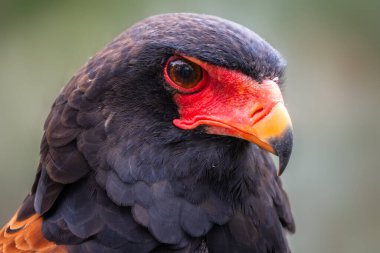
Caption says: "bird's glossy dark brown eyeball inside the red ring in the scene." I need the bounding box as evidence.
[166,58,203,90]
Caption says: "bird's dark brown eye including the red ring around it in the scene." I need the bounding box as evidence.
[164,56,207,93]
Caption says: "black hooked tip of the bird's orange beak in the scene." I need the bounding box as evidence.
[270,128,293,176]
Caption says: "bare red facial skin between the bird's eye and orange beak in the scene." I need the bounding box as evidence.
[164,56,283,153]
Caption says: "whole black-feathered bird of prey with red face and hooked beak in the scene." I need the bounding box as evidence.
[0,13,295,253]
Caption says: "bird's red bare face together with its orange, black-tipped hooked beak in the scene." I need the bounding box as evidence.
[173,58,293,175]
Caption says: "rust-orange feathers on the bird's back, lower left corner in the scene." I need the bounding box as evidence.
[0,212,67,253]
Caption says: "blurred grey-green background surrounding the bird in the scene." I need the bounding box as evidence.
[0,0,380,253]
